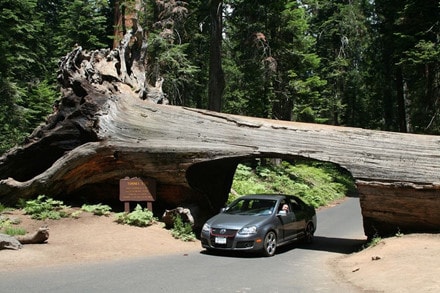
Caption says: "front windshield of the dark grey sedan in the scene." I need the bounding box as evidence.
[224,198,277,216]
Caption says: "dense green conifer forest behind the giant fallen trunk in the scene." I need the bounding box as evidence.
[0,0,440,153]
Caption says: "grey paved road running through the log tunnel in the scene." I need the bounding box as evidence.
[0,198,365,293]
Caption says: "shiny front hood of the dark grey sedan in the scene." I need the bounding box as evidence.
[207,213,270,230]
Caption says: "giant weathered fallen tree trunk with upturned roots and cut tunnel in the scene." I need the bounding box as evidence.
[0,34,440,236]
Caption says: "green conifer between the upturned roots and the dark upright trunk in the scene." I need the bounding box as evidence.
[145,1,199,105]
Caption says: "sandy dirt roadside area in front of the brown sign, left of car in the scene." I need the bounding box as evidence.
[0,211,201,272]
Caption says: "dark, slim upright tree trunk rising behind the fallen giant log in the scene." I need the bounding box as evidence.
[208,0,225,112]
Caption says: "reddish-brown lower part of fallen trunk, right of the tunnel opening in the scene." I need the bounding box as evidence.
[357,181,440,237]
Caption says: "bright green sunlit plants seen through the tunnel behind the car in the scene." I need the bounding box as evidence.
[228,159,356,207]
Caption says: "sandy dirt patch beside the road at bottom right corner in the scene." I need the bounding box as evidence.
[331,234,440,293]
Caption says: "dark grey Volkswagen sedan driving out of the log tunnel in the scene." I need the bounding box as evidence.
[200,194,316,256]
